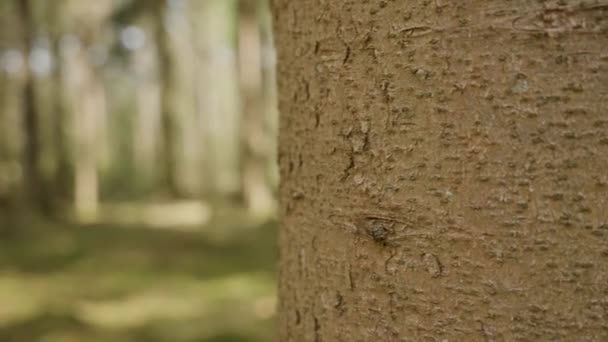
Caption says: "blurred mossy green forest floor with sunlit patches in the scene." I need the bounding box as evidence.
[0,206,276,342]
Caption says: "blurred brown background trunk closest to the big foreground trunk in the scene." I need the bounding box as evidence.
[238,0,274,217]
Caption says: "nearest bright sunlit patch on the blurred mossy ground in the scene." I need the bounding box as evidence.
[77,274,274,329]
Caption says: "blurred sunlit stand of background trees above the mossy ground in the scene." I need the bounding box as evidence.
[0,0,278,220]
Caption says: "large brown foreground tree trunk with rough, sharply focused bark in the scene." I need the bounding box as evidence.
[274,0,608,341]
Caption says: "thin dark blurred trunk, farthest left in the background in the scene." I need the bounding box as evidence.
[17,0,49,211]
